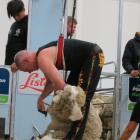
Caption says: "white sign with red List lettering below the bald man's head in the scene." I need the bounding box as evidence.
[18,71,47,94]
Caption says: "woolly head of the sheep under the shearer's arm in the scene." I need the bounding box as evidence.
[48,85,85,121]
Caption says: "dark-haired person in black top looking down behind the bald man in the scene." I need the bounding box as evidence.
[5,0,28,70]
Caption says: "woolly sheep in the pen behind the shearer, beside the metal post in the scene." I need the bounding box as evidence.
[92,93,113,140]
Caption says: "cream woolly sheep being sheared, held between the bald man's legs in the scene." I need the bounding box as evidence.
[38,85,102,140]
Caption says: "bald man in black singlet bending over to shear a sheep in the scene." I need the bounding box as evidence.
[15,39,104,140]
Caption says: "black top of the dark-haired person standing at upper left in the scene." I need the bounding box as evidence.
[5,16,28,65]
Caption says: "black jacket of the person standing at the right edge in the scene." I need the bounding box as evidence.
[122,34,140,73]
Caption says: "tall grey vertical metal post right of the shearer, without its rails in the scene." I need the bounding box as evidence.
[112,0,123,140]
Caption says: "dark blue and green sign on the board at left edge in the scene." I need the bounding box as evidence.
[0,68,10,104]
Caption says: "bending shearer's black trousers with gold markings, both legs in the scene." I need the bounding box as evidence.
[65,46,104,140]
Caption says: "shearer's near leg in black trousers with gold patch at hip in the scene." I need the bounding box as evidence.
[75,46,104,140]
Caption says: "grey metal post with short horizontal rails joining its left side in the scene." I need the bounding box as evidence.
[93,0,124,140]
